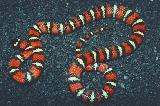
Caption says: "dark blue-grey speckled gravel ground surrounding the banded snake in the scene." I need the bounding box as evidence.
[0,0,160,106]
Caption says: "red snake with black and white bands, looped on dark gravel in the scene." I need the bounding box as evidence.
[8,4,146,102]
